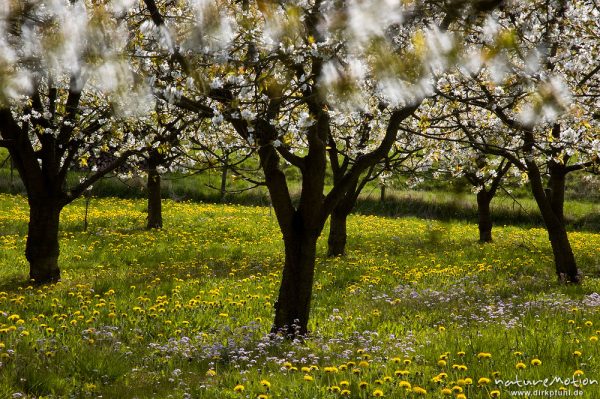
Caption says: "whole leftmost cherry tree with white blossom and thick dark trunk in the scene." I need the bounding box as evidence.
[0,0,150,283]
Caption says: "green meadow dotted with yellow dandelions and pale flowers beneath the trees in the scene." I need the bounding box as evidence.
[0,194,600,399]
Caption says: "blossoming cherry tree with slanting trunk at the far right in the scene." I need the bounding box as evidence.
[426,1,600,282]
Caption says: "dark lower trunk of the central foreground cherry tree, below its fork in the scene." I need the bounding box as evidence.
[272,227,318,337]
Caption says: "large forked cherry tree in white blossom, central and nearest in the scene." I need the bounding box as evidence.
[130,0,501,336]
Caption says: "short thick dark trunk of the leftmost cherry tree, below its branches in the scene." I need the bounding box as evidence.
[25,199,61,284]
